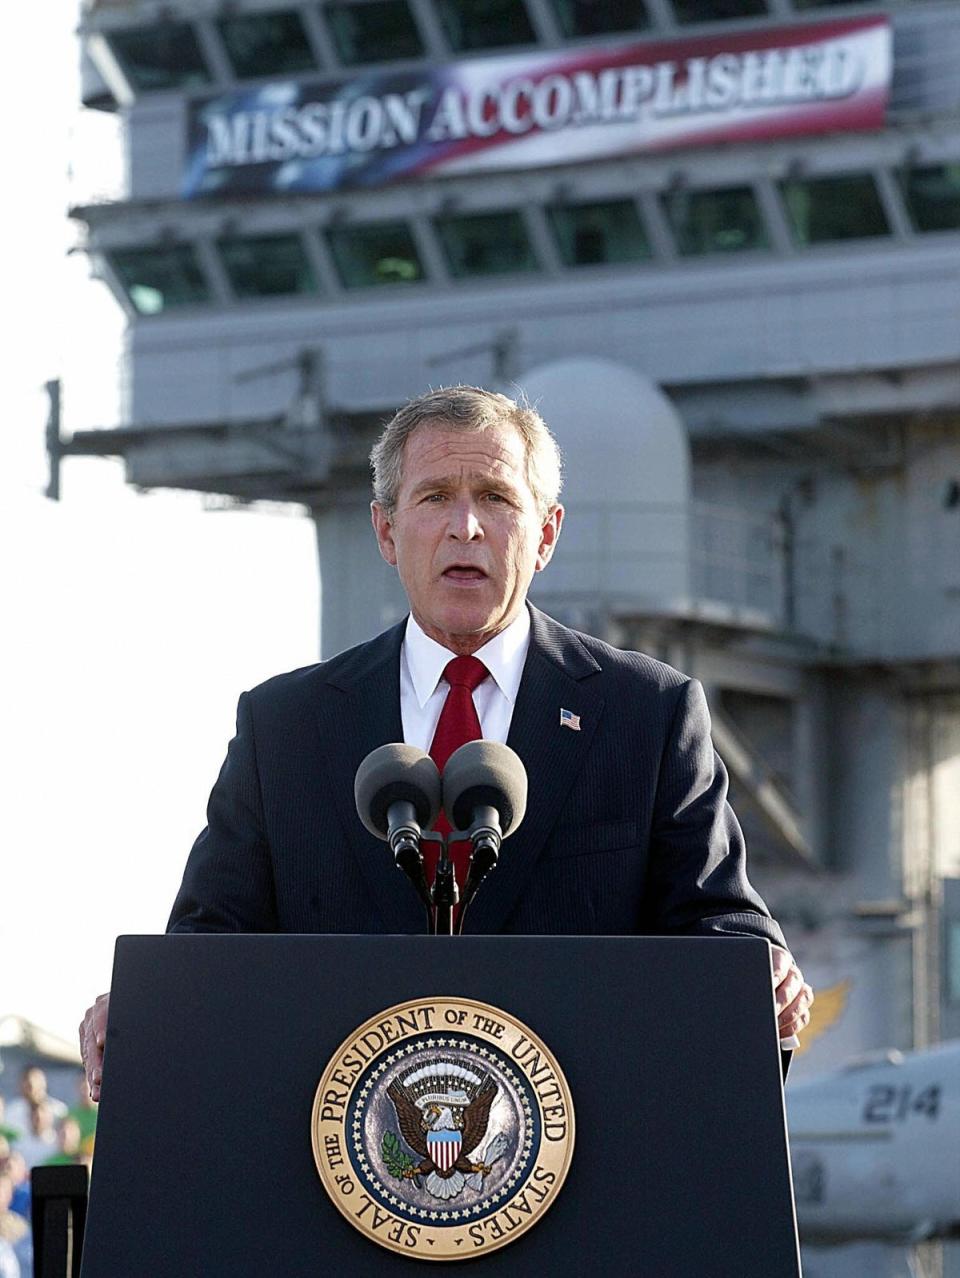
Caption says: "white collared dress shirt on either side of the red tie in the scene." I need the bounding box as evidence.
[400,607,530,751]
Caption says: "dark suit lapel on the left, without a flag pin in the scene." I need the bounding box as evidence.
[318,621,427,933]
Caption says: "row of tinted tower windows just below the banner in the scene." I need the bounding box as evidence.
[109,164,960,314]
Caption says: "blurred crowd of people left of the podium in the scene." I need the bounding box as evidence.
[0,1065,97,1278]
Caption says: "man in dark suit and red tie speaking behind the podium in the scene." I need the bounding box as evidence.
[81,387,813,1097]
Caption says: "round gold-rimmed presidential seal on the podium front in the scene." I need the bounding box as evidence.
[311,998,574,1260]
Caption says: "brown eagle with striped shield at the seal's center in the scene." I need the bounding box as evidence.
[387,1075,502,1199]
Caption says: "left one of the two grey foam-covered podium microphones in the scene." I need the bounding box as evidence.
[353,743,440,909]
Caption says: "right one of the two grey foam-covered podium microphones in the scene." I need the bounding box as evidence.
[442,740,527,930]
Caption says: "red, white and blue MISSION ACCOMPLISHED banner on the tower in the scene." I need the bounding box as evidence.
[183,17,891,198]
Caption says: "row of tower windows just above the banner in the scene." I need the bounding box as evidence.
[106,0,910,93]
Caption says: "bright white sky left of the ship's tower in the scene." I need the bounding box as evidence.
[0,0,318,1038]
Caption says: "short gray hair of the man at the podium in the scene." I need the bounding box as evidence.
[369,386,562,519]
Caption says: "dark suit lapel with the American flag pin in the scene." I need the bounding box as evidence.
[467,607,603,933]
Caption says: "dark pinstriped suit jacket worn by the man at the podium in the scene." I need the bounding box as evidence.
[169,608,784,944]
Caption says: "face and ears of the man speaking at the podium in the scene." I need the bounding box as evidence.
[372,423,564,654]
